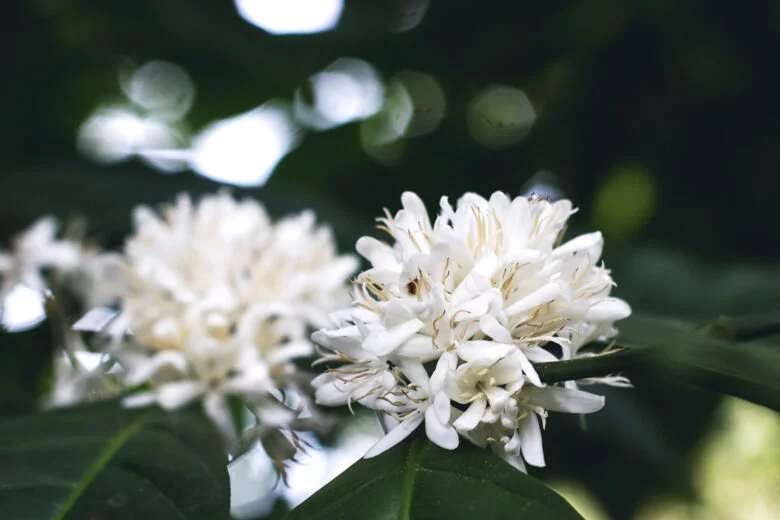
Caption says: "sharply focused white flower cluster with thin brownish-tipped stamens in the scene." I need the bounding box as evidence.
[313,192,631,469]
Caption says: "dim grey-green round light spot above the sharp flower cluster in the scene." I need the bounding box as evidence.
[468,86,536,149]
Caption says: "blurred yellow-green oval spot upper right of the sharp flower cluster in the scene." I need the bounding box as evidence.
[593,163,657,237]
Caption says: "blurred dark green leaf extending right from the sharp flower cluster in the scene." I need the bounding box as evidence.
[619,316,780,411]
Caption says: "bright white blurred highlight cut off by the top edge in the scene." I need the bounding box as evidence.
[235,0,344,34]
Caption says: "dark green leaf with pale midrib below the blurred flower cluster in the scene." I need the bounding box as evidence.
[0,402,230,520]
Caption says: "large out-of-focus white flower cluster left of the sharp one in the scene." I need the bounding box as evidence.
[109,192,357,440]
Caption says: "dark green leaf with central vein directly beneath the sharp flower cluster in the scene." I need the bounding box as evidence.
[285,436,581,520]
